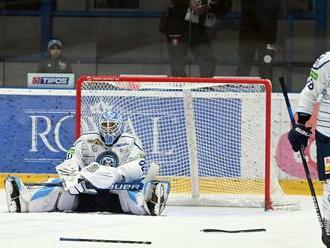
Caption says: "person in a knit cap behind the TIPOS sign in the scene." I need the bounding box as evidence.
[38,39,72,73]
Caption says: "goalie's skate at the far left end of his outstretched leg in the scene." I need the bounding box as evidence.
[5,176,24,213]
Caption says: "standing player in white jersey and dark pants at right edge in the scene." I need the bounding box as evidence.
[288,52,330,247]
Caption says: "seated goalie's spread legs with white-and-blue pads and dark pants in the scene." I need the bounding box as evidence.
[5,176,170,215]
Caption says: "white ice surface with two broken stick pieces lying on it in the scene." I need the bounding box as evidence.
[0,190,324,248]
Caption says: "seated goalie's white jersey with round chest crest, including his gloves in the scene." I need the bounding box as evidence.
[56,132,145,189]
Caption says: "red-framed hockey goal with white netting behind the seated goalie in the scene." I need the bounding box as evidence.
[76,76,296,209]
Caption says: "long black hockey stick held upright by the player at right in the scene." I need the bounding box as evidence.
[279,77,329,240]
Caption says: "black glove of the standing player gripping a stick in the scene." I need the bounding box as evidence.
[288,124,312,152]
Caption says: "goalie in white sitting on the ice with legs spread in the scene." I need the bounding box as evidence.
[5,111,169,215]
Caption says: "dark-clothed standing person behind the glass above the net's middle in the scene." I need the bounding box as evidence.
[161,0,231,77]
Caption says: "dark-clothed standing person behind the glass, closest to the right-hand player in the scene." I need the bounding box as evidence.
[237,0,280,80]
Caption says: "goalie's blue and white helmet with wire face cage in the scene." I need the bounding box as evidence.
[99,111,124,146]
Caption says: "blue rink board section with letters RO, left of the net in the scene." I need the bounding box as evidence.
[0,89,75,174]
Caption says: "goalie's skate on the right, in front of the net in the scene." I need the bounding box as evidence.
[145,181,170,216]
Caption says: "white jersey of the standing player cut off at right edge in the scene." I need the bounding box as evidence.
[297,52,330,137]
